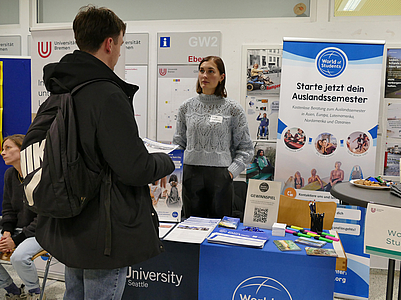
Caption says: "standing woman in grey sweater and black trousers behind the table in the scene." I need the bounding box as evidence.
[173,56,253,218]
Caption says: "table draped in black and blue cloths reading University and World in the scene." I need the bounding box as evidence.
[123,225,336,300]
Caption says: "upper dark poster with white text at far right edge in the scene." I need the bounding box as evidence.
[384,48,401,98]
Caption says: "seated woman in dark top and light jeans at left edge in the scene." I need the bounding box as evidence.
[0,134,45,299]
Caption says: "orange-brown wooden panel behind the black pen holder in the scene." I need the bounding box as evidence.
[277,195,337,230]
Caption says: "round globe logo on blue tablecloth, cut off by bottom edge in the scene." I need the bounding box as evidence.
[232,276,292,300]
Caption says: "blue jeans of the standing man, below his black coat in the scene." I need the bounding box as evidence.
[63,266,127,300]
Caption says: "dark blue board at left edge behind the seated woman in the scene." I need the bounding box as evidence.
[0,56,31,211]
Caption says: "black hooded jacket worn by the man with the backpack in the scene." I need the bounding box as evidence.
[36,50,174,269]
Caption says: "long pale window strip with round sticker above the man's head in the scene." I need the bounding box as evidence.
[36,0,310,23]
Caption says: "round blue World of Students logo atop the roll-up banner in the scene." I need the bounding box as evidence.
[316,47,348,78]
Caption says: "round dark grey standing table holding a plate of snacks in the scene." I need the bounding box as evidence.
[330,182,401,300]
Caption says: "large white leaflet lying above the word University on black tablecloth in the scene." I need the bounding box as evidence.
[164,217,220,244]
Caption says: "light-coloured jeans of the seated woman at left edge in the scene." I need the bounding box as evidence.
[0,237,42,291]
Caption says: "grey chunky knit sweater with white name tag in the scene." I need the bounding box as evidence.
[173,94,253,178]
